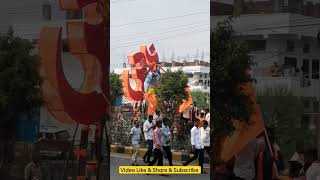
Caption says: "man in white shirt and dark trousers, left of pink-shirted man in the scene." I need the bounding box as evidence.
[143,115,155,163]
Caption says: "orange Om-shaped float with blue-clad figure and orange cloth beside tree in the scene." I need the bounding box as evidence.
[122,44,193,115]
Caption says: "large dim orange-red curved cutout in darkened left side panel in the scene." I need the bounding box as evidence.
[40,0,110,124]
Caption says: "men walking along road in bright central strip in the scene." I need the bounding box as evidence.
[129,111,211,173]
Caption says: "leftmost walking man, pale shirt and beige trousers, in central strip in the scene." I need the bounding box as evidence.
[129,122,141,166]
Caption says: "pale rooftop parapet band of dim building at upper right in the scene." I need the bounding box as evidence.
[211,13,320,37]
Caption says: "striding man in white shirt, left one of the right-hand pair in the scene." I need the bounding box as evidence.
[183,118,206,173]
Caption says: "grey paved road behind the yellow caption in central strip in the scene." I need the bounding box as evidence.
[110,153,210,180]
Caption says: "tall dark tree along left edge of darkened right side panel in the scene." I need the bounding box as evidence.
[210,19,253,167]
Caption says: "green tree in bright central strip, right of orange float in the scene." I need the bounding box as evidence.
[155,69,188,120]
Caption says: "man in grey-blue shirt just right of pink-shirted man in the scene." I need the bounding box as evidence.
[161,117,174,166]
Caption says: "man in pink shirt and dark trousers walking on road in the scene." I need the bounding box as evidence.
[148,120,164,166]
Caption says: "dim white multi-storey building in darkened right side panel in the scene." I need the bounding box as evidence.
[211,13,320,128]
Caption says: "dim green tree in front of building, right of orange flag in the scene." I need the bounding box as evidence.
[258,88,315,160]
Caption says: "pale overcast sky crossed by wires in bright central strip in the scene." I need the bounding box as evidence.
[110,0,210,70]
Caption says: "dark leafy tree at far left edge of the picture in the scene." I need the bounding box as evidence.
[0,28,42,165]
